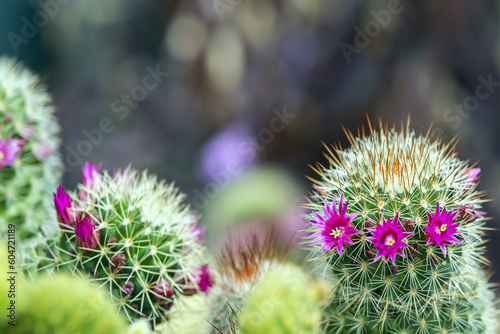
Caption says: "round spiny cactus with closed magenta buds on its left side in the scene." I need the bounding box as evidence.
[41,164,213,326]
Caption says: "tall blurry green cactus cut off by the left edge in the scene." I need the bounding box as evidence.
[0,57,62,269]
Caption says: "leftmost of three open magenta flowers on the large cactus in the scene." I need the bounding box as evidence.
[309,195,362,257]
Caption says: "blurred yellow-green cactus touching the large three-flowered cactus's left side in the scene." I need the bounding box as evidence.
[239,265,326,334]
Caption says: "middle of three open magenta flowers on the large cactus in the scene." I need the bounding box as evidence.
[366,213,413,264]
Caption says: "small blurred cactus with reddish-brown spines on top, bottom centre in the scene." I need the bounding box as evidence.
[208,231,289,333]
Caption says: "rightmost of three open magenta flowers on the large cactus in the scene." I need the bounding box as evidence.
[424,203,463,257]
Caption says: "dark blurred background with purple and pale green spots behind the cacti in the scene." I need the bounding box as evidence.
[0,0,500,282]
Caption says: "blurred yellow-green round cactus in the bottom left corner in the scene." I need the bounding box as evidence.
[0,275,127,334]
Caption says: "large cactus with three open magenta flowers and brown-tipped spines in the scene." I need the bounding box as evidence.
[307,122,498,334]
